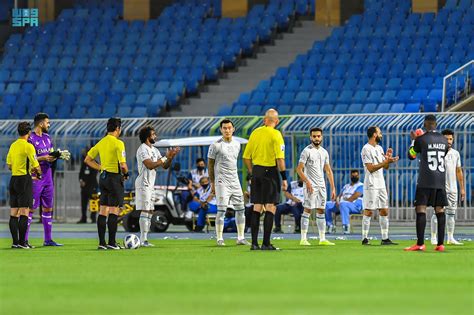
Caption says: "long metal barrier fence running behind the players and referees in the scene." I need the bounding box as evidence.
[0,112,474,222]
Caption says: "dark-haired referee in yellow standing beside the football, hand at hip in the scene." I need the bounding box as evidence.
[84,118,129,250]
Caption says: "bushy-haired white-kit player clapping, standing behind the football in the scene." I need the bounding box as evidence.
[135,126,180,247]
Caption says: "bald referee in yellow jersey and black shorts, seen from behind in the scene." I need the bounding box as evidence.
[243,109,288,250]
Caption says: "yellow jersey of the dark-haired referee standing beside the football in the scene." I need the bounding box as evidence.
[87,135,127,173]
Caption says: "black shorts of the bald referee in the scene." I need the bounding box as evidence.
[250,165,281,204]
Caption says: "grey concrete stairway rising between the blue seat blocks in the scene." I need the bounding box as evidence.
[170,21,332,117]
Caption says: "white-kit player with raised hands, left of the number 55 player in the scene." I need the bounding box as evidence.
[361,126,398,245]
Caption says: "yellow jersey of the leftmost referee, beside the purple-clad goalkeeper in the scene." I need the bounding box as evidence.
[7,139,39,176]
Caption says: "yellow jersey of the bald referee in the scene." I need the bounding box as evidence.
[243,126,285,167]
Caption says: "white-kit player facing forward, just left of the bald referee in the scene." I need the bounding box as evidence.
[207,119,250,246]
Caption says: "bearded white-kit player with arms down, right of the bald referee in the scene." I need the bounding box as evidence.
[296,128,336,246]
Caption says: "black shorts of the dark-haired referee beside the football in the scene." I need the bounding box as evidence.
[99,171,124,207]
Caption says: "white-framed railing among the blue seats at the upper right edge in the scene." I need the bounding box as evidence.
[441,60,474,112]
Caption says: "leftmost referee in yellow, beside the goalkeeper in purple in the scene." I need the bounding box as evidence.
[7,121,41,249]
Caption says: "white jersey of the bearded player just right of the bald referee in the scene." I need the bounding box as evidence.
[299,144,329,188]
